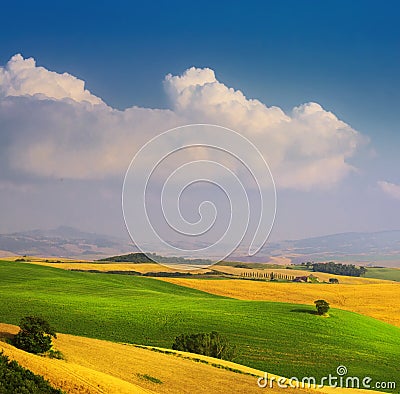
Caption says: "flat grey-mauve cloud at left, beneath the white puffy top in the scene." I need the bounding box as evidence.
[0,97,177,179]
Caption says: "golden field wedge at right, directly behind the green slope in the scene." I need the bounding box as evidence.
[157,278,400,327]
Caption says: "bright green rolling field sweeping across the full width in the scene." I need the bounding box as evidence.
[0,262,400,390]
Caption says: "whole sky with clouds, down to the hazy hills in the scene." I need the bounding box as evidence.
[0,0,400,252]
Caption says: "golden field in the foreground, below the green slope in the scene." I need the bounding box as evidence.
[0,323,382,394]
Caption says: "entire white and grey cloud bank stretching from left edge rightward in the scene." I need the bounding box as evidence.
[0,55,366,189]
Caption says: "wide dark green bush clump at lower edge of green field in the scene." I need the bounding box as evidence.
[172,331,235,360]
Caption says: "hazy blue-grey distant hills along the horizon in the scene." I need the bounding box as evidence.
[0,226,400,267]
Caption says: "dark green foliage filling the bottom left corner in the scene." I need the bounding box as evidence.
[0,352,63,394]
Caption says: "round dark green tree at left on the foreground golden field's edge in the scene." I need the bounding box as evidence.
[12,316,57,354]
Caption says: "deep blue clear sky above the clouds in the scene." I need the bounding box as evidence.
[0,1,400,115]
